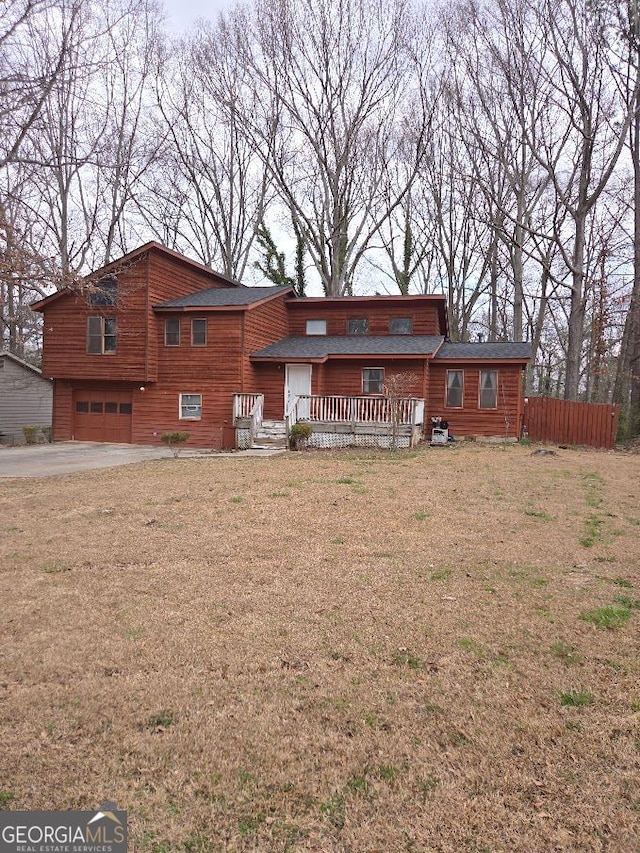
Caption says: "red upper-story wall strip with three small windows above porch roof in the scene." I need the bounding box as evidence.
[289,297,441,336]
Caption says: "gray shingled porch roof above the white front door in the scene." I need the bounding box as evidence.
[251,335,444,361]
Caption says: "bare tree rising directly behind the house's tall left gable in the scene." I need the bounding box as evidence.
[147,26,269,278]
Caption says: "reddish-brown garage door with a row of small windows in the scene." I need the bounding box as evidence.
[73,388,133,444]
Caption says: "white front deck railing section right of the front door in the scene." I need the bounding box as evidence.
[288,394,424,426]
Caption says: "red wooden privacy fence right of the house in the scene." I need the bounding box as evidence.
[523,397,620,448]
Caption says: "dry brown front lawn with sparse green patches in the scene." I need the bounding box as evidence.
[0,445,640,853]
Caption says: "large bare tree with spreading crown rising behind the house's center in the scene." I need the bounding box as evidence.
[222,0,424,296]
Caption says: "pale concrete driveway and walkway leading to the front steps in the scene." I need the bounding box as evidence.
[0,441,285,479]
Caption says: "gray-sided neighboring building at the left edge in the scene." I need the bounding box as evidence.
[0,352,53,444]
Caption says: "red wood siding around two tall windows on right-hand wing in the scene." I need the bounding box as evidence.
[426,362,523,438]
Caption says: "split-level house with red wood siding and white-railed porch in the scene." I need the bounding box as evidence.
[32,243,530,447]
